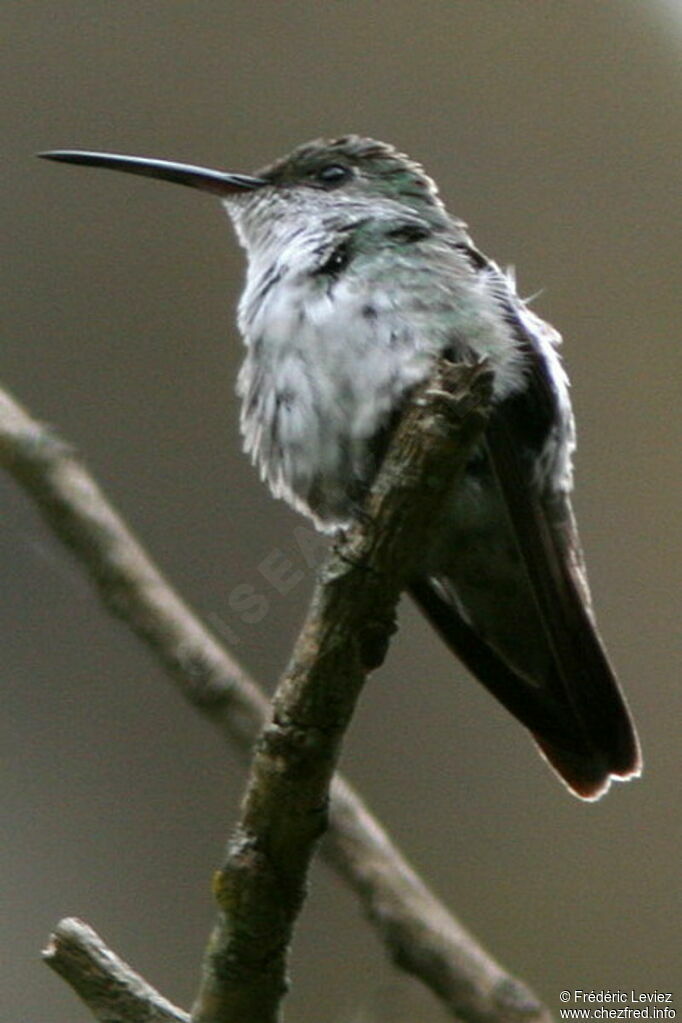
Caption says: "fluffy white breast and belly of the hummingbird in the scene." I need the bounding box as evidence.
[237,221,560,529]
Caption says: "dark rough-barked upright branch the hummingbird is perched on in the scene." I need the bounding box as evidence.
[192,365,507,1023]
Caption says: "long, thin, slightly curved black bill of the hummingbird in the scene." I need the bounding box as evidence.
[38,149,267,197]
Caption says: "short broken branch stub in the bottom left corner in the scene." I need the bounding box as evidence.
[43,917,189,1023]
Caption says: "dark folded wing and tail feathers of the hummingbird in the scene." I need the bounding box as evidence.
[411,252,640,799]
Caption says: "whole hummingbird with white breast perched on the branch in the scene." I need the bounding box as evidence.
[41,135,641,800]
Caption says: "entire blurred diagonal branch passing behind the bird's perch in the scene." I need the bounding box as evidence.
[0,376,546,1023]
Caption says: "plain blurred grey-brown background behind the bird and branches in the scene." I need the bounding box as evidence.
[0,0,682,1023]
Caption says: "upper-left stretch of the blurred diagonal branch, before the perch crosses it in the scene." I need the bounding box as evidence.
[0,391,268,749]
